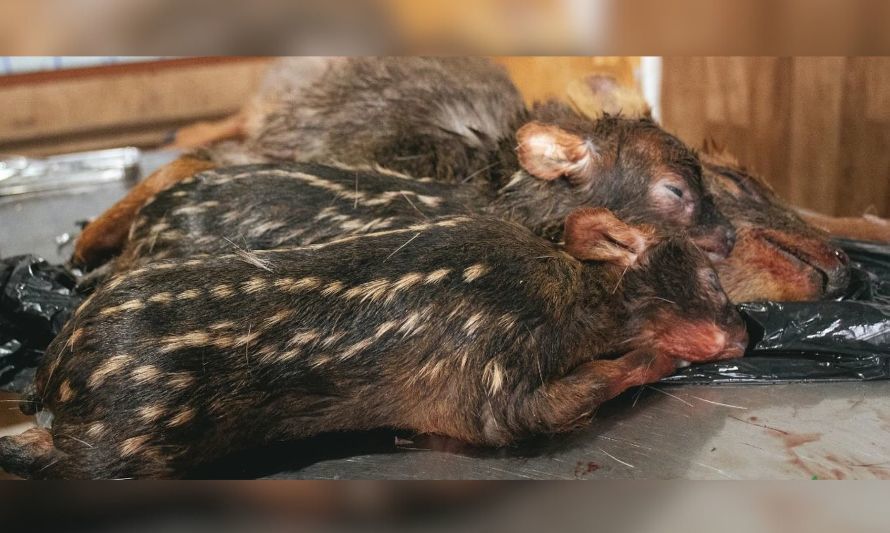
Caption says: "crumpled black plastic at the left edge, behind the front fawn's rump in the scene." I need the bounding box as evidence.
[0,255,82,392]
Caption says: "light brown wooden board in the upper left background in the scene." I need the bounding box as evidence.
[0,57,269,155]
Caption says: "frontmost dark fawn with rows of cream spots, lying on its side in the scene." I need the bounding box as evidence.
[0,208,746,478]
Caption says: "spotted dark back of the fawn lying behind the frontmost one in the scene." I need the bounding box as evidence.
[114,163,488,271]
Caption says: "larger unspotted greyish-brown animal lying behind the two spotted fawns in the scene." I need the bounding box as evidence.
[73,58,734,266]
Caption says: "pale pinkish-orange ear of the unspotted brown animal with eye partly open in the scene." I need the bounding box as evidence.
[516,121,599,184]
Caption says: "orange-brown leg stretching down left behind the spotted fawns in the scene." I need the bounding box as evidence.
[72,155,216,268]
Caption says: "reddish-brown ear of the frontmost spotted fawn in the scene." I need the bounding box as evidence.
[565,207,655,267]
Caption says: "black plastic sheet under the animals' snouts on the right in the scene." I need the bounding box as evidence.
[663,240,890,384]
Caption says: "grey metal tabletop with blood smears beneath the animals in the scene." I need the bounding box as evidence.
[0,153,890,479]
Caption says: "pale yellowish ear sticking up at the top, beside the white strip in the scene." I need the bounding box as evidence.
[566,74,652,120]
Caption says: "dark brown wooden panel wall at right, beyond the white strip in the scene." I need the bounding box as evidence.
[662,57,890,216]
